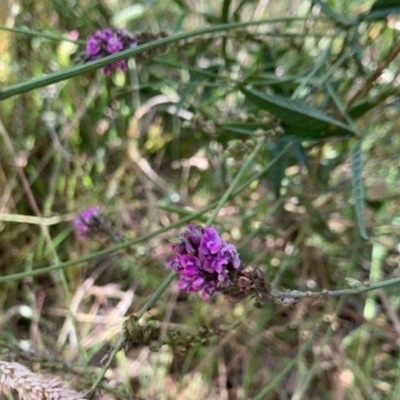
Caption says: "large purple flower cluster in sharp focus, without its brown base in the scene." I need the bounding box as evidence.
[167,224,241,300]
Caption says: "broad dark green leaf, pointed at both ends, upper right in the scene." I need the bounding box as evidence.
[240,87,354,139]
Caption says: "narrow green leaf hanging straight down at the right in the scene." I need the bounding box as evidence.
[351,140,368,239]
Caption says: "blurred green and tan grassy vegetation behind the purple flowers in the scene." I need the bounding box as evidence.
[0,0,400,400]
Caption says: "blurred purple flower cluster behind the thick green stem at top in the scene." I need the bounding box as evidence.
[86,28,136,76]
